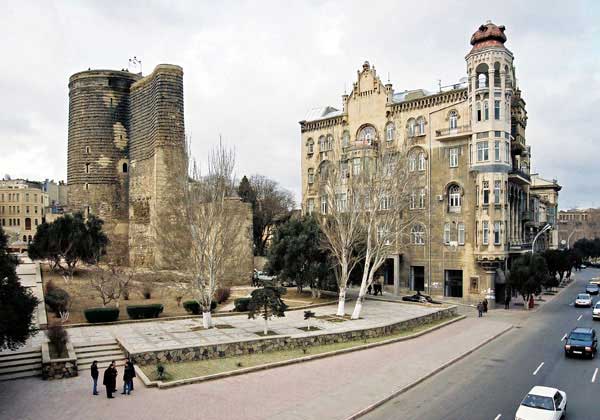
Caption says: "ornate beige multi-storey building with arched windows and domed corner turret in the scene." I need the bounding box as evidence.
[300,22,556,300]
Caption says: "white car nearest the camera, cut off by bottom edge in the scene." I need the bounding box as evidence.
[515,386,567,420]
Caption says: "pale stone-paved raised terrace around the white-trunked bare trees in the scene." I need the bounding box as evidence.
[69,301,439,353]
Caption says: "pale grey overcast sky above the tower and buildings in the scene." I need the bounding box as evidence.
[0,0,600,208]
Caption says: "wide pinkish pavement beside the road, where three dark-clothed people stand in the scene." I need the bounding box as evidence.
[0,317,512,420]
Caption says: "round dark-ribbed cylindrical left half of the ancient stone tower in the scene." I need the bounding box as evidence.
[67,70,141,262]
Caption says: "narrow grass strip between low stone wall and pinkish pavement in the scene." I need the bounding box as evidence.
[140,318,460,382]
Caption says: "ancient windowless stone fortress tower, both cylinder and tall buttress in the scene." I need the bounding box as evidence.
[67,64,253,283]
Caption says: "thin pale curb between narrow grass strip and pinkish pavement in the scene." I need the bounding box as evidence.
[139,315,466,389]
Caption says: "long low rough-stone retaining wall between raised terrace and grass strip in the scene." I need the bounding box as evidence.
[124,306,457,366]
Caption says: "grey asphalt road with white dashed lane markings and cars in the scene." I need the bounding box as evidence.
[364,268,600,420]
